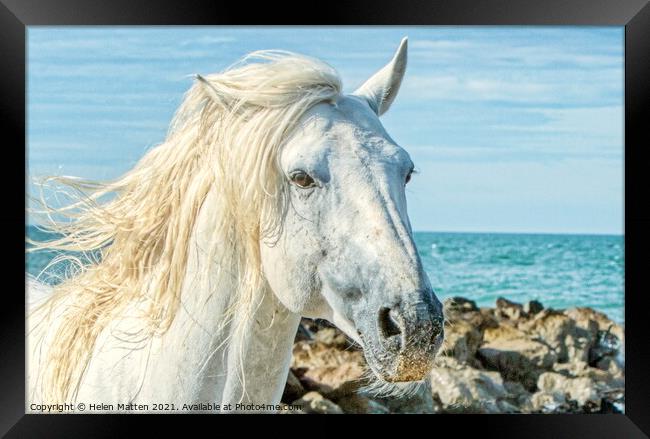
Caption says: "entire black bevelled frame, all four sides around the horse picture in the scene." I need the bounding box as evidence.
[0,0,650,439]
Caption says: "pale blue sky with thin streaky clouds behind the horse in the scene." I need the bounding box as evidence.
[27,26,624,234]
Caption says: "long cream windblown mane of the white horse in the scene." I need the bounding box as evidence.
[29,51,341,402]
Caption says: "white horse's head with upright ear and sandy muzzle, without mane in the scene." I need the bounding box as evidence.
[261,39,444,382]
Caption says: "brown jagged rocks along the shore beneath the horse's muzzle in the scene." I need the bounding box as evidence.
[282,297,625,413]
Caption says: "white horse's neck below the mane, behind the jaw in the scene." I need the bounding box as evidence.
[144,191,300,410]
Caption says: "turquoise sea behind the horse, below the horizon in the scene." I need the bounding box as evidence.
[25,226,625,324]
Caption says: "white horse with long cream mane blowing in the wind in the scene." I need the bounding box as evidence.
[27,38,443,411]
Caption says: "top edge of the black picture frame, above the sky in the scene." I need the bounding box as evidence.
[2,0,646,26]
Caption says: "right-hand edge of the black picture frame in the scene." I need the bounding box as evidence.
[625,3,650,433]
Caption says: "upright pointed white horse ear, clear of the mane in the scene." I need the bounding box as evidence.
[352,37,408,116]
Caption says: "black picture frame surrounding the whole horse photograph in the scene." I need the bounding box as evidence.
[0,0,650,439]
